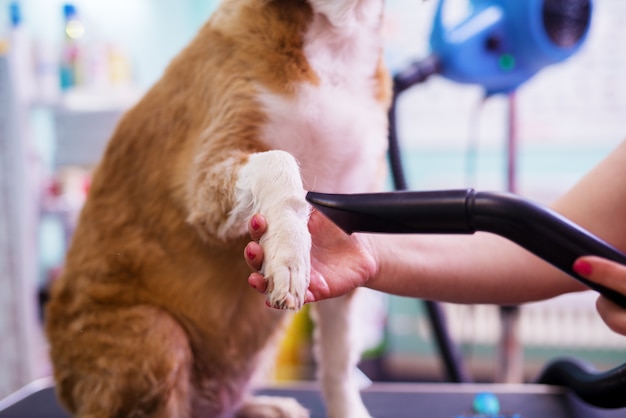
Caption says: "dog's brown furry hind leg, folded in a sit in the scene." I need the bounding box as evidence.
[49,306,192,418]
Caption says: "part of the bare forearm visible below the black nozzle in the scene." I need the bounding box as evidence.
[368,233,583,304]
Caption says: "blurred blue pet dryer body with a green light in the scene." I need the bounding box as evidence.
[430,0,592,94]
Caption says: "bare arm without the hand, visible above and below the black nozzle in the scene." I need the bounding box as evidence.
[368,141,626,304]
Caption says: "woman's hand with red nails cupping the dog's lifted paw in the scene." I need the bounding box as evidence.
[245,211,377,303]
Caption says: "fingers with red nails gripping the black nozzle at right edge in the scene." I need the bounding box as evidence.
[574,256,626,335]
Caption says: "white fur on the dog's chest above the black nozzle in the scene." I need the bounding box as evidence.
[259,1,387,193]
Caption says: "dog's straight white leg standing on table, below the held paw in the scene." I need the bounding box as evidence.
[312,294,370,418]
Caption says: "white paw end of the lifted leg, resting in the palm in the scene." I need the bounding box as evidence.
[260,212,311,310]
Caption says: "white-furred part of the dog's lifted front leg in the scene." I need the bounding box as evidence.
[229,150,311,310]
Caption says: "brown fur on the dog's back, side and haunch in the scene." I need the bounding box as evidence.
[46,0,387,417]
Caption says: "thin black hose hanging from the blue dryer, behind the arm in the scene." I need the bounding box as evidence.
[389,56,471,383]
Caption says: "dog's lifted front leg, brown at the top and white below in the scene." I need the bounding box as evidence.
[189,150,311,310]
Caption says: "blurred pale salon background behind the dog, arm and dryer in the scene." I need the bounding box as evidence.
[0,0,626,398]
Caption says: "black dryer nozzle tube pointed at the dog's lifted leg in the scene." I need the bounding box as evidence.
[307,189,626,308]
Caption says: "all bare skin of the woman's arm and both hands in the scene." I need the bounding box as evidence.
[245,141,626,335]
